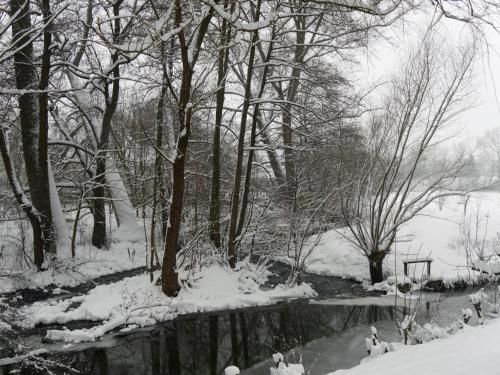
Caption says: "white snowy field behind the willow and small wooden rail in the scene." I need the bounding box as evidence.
[307,192,500,282]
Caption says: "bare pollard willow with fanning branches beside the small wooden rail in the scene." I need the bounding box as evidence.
[339,33,474,283]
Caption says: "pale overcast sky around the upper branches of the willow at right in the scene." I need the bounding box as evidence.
[352,10,500,148]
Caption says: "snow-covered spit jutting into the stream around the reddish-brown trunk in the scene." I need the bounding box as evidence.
[18,262,316,342]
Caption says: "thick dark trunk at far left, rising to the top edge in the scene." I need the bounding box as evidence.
[10,0,56,269]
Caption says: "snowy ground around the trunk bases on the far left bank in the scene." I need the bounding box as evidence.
[0,211,146,294]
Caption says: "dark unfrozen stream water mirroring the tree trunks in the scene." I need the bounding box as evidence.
[3,302,393,375]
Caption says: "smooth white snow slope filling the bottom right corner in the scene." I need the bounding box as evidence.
[329,319,500,375]
